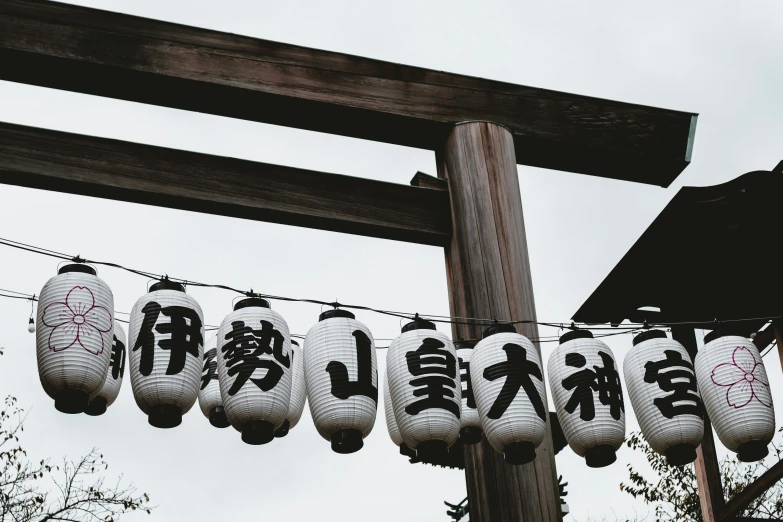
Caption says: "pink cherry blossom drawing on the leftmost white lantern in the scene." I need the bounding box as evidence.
[43,286,112,355]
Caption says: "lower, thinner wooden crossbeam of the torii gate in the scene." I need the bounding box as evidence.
[0,121,451,246]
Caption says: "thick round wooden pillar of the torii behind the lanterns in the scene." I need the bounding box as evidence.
[437,122,561,522]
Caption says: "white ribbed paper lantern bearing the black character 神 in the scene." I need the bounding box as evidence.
[548,330,625,468]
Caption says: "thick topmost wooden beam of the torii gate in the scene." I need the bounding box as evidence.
[0,0,696,186]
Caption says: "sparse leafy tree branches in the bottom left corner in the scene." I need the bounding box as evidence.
[0,397,153,522]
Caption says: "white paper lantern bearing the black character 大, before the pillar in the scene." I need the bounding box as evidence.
[470,325,547,464]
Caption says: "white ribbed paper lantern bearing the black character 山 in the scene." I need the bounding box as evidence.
[304,309,378,453]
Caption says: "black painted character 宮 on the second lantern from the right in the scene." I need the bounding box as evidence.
[644,350,704,419]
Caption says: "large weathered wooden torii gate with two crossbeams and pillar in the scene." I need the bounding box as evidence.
[0,0,696,522]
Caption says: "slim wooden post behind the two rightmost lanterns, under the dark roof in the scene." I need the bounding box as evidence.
[672,326,726,522]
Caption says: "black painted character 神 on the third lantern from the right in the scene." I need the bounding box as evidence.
[561,351,625,421]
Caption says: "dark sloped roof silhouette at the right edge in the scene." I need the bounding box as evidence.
[573,161,783,332]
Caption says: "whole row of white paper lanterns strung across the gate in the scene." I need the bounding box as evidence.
[36,264,775,467]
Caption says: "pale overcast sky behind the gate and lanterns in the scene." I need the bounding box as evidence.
[0,0,783,522]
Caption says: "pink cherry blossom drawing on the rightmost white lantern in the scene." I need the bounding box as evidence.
[712,346,772,408]
